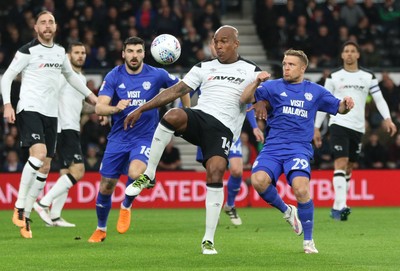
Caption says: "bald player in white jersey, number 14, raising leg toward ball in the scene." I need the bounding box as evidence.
[124,25,270,254]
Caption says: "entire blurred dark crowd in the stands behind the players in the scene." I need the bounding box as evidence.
[0,0,400,172]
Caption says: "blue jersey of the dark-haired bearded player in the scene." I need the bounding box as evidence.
[99,64,179,143]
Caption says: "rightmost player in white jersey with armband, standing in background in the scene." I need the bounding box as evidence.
[314,41,397,221]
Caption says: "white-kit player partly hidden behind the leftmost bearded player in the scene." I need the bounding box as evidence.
[33,42,101,227]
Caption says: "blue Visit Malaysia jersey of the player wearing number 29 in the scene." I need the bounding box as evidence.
[255,79,340,155]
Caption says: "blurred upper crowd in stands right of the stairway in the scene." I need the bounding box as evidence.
[254,0,400,71]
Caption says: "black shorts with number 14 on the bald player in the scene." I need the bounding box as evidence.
[175,108,233,166]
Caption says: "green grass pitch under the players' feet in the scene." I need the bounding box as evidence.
[0,207,400,271]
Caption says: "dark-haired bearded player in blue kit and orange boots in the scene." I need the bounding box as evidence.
[88,37,190,243]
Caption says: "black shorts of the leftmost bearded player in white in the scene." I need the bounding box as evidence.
[17,110,57,158]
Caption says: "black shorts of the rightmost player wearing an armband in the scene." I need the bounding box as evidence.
[329,124,363,163]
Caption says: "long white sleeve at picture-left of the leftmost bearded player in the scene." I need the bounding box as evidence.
[1,51,30,104]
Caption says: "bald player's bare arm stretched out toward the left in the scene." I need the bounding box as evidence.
[124,81,192,130]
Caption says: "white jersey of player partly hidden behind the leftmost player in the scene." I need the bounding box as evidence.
[58,73,86,132]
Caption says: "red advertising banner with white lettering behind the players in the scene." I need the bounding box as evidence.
[0,170,400,209]
